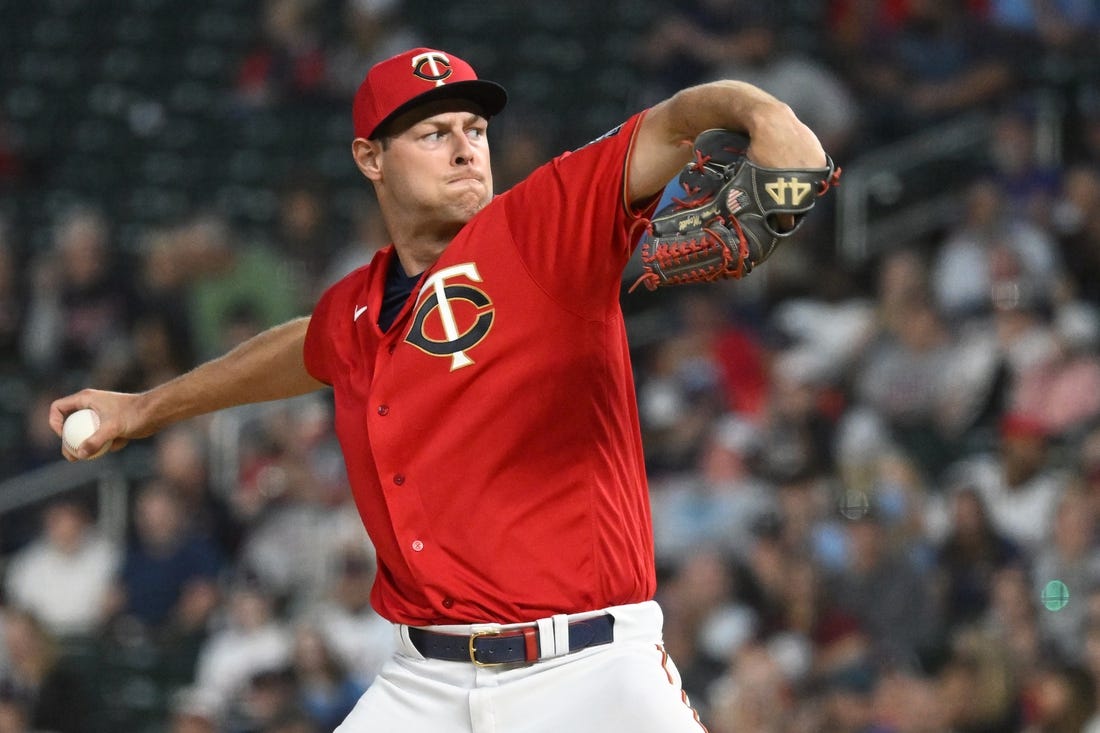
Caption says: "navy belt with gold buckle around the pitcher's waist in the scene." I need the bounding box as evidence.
[409,613,615,667]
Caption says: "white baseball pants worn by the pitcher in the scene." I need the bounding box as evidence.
[336,601,706,733]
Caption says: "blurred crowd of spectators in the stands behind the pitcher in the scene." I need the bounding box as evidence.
[0,0,1100,733]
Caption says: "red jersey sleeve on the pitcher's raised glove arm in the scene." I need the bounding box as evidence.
[502,112,657,309]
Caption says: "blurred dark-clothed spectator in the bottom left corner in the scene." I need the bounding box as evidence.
[0,611,91,733]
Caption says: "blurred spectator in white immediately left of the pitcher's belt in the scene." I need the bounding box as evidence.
[301,543,395,687]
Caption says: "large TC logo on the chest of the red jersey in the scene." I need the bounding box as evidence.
[405,262,495,372]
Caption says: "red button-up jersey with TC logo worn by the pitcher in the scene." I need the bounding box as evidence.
[305,114,656,625]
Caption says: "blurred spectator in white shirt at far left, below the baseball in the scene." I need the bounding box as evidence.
[4,497,120,637]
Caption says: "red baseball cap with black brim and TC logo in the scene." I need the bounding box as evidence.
[352,48,508,139]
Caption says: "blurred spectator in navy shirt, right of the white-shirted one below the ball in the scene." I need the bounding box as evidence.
[110,479,223,635]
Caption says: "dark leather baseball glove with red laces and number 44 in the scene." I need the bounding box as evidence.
[630,130,840,292]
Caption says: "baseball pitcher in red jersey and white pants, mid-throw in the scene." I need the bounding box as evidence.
[51,48,836,733]
